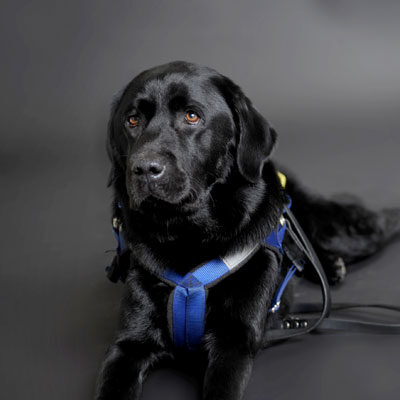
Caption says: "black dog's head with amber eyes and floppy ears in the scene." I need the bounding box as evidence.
[108,62,276,209]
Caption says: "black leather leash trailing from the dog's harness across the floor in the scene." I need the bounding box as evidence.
[265,206,400,346]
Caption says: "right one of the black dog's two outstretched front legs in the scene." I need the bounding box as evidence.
[203,344,254,400]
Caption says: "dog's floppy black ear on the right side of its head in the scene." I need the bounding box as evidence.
[214,77,277,183]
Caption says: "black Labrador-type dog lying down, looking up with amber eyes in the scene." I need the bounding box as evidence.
[96,62,400,400]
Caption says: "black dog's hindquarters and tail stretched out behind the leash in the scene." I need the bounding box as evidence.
[287,179,400,264]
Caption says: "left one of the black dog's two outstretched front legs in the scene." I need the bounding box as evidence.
[95,341,165,400]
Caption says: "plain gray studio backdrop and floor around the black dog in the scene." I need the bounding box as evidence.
[0,0,400,400]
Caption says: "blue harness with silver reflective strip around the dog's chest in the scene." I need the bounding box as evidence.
[113,198,297,350]
